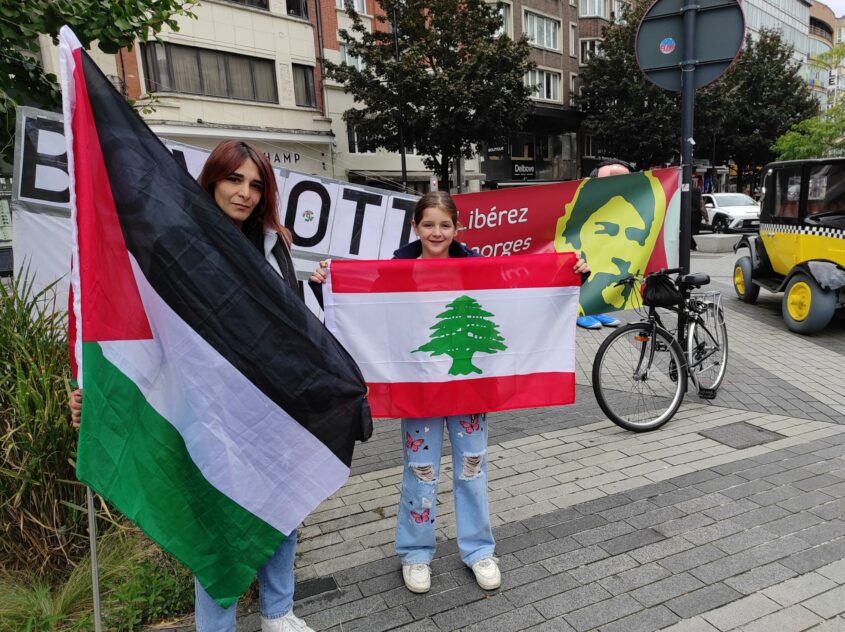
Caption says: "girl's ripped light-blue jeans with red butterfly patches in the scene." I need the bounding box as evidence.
[396,414,495,566]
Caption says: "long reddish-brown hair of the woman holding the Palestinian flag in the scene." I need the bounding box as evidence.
[198,140,292,246]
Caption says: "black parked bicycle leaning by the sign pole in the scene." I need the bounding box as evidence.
[593,268,728,432]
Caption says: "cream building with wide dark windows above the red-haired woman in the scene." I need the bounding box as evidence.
[42,0,336,177]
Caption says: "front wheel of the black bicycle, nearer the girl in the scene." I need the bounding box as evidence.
[593,323,687,432]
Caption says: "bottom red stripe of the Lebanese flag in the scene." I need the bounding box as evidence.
[367,373,575,417]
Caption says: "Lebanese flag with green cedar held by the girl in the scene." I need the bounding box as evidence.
[324,253,580,417]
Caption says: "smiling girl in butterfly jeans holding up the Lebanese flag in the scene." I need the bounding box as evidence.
[311,191,589,593]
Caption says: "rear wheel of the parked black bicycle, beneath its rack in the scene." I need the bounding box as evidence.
[687,302,728,396]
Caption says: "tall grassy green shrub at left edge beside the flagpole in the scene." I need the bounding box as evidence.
[0,273,88,576]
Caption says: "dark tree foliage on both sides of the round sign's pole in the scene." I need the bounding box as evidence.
[578,9,818,180]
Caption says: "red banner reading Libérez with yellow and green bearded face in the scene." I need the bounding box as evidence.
[454,168,680,314]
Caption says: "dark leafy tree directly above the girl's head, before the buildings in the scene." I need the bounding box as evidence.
[324,0,534,186]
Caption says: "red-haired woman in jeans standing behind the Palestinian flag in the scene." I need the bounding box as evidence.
[70,140,313,632]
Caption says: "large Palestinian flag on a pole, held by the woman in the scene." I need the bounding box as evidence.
[61,28,369,606]
